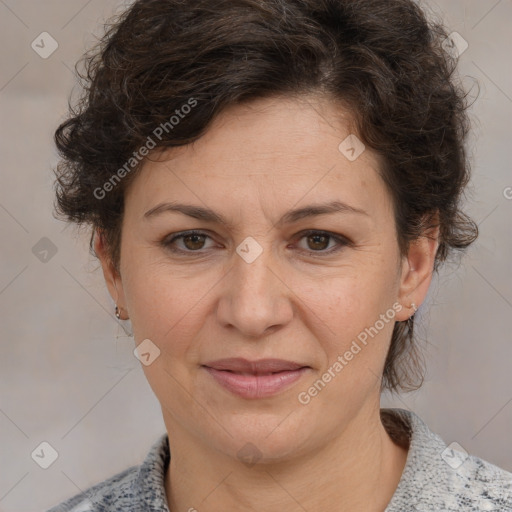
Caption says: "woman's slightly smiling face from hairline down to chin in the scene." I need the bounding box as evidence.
[97,94,432,461]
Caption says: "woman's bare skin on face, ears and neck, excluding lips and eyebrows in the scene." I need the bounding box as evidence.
[95,97,438,512]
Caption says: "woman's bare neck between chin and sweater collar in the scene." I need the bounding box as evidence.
[165,405,407,512]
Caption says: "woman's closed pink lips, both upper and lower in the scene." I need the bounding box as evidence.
[202,358,312,399]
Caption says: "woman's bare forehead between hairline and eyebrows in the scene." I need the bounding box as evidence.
[127,97,389,221]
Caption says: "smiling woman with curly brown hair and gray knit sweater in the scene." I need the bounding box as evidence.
[47,0,512,512]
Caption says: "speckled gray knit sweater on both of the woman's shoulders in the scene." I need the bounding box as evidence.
[48,409,512,512]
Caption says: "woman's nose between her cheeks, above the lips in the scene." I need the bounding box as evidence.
[217,242,293,338]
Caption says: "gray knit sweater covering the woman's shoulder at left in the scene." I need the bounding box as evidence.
[47,434,170,512]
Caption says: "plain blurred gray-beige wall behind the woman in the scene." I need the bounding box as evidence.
[0,0,512,511]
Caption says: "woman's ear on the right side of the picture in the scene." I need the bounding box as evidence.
[396,215,439,321]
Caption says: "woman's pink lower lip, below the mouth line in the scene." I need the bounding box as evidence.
[203,366,309,398]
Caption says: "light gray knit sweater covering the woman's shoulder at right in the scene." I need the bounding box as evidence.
[383,409,512,512]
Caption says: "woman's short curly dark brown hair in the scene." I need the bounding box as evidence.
[55,0,478,392]
